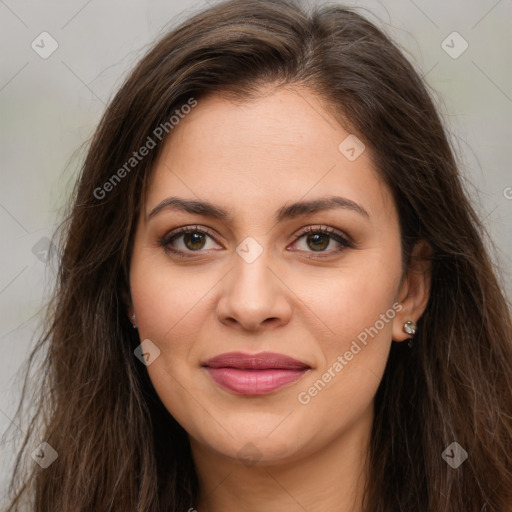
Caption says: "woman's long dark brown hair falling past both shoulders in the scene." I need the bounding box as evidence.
[8,0,512,512]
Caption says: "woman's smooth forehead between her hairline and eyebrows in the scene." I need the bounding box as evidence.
[146,87,396,224]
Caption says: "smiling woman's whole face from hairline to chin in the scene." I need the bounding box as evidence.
[130,88,419,464]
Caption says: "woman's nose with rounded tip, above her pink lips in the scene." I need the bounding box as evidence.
[217,251,292,331]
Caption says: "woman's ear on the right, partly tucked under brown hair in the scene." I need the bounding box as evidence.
[393,240,432,342]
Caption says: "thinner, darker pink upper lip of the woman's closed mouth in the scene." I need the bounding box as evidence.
[202,352,310,370]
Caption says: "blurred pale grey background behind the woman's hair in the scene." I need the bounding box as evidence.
[0,0,512,503]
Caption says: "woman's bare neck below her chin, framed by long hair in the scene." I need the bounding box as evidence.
[191,407,373,512]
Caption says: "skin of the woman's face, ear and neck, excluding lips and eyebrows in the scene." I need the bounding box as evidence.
[129,87,429,512]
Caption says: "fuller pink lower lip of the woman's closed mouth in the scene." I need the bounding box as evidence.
[207,368,309,395]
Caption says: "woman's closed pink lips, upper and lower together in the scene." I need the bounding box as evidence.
[202,352,311,395]
